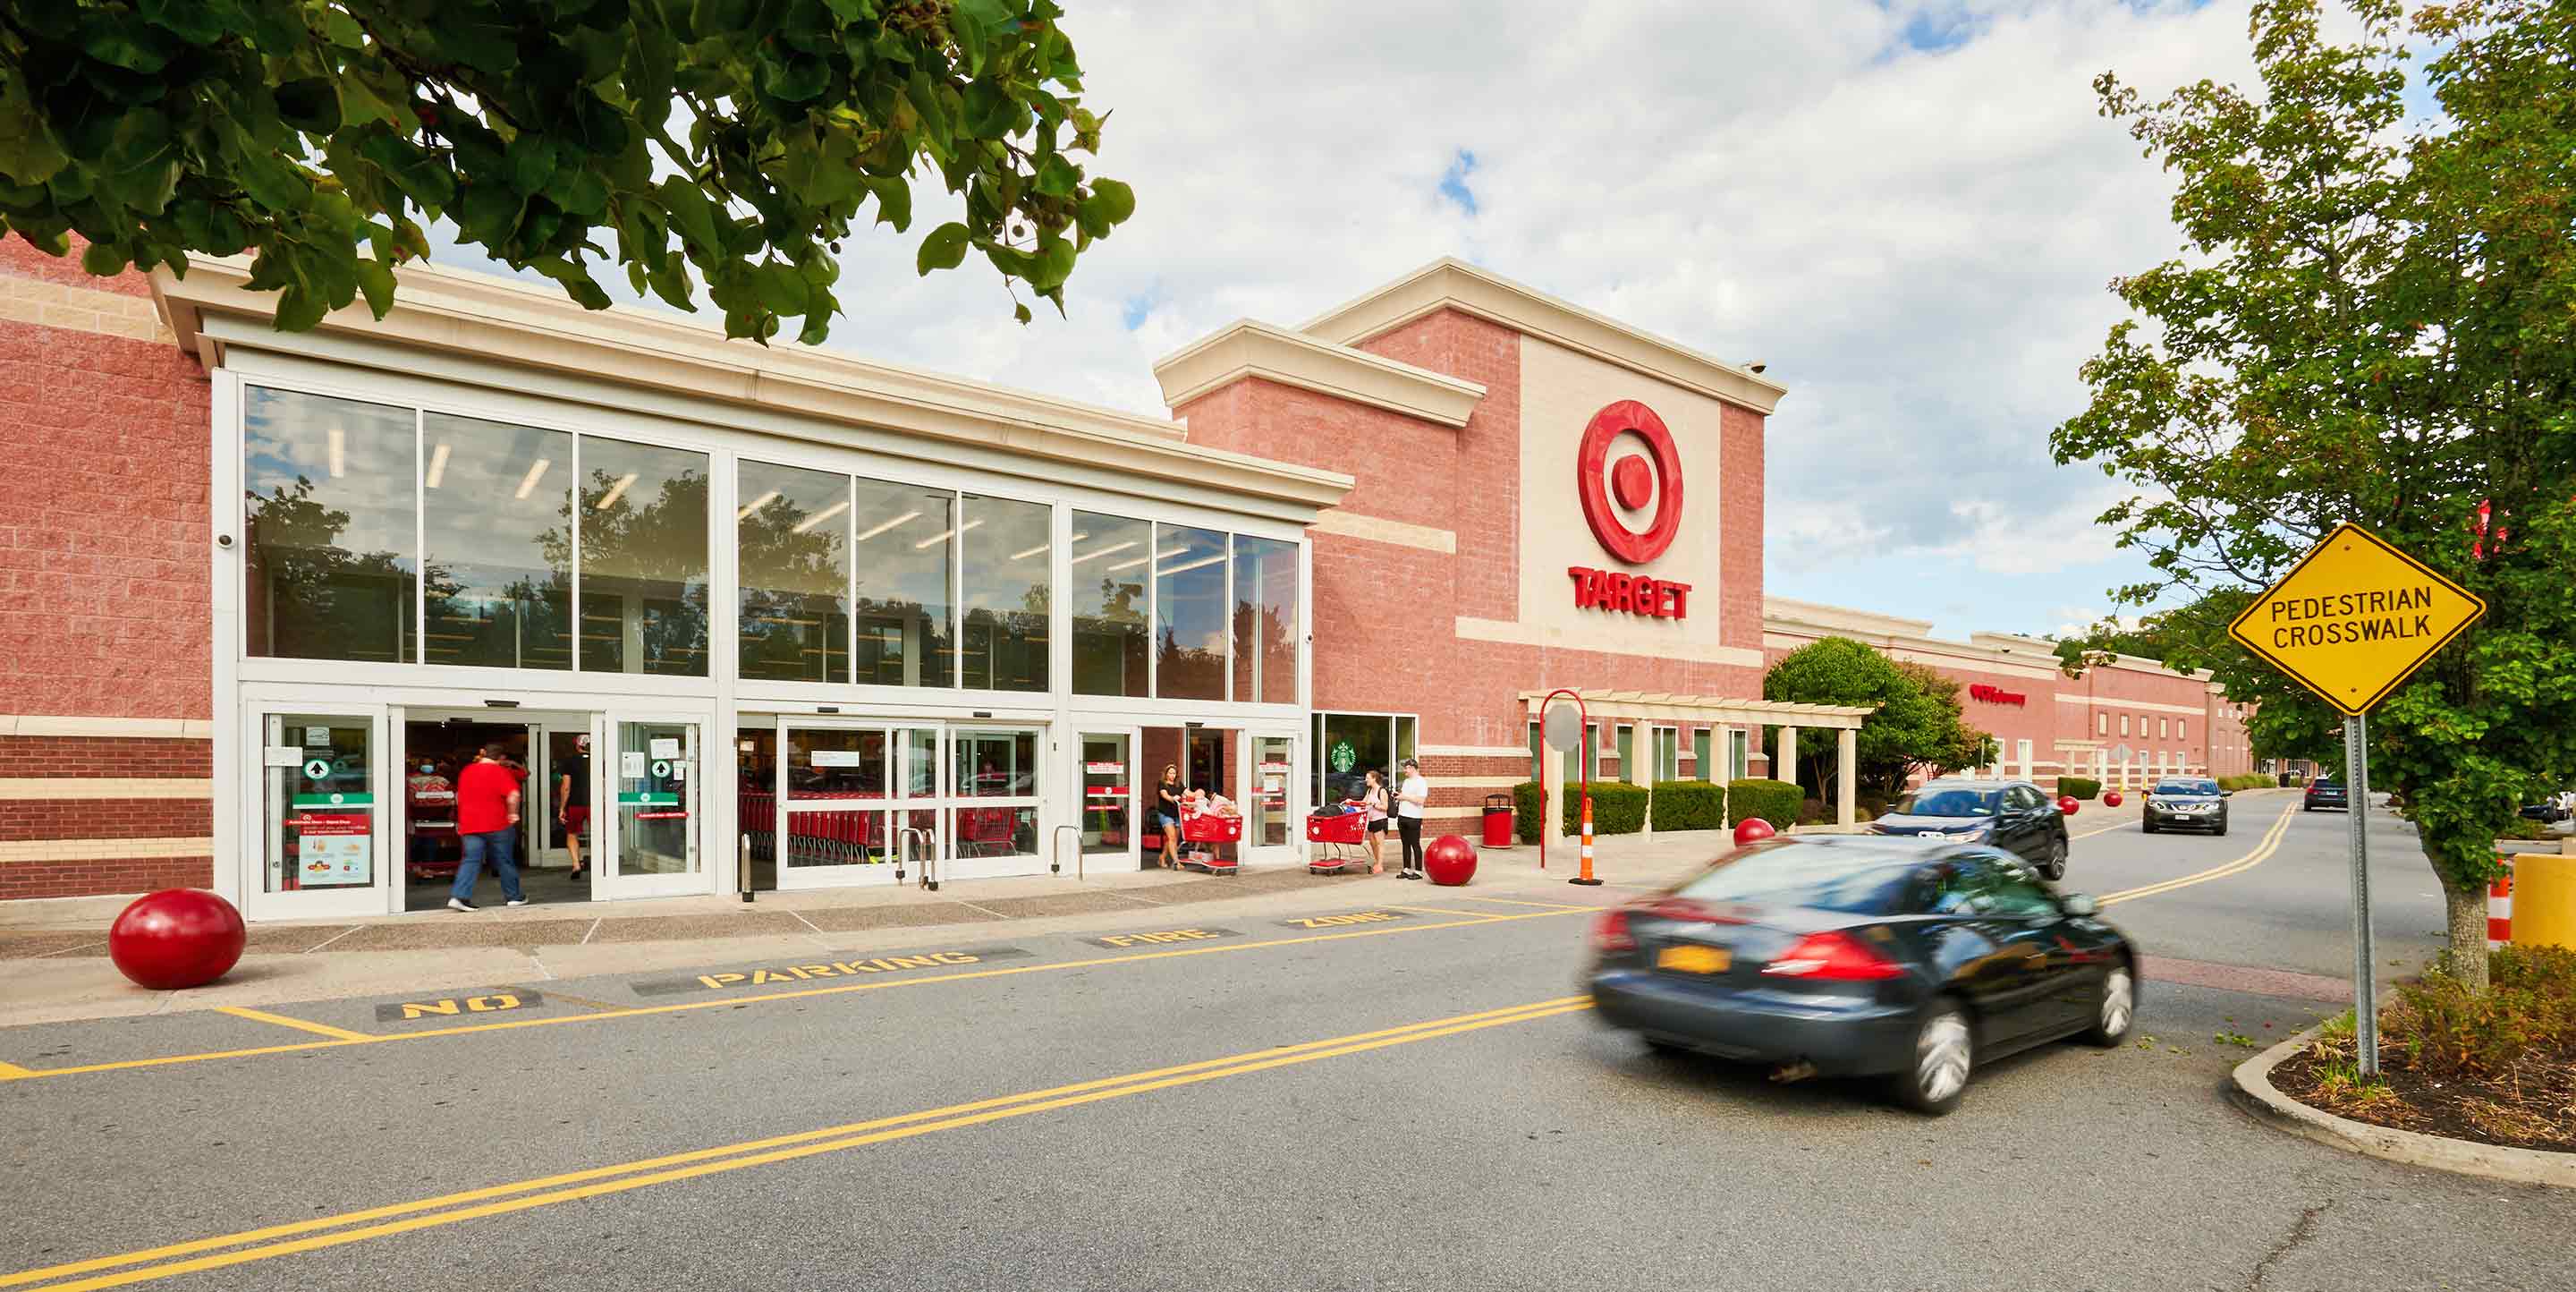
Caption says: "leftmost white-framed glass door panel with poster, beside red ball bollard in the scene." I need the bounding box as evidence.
[242,707,392,921]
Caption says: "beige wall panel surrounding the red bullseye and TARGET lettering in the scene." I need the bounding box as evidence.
[1520,336,1759,663]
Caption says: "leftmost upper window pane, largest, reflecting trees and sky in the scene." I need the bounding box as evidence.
[242,387,419,663]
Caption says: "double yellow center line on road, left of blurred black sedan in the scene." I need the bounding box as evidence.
[0,996,1592,1292]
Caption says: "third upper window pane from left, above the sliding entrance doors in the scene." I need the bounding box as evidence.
[580,436,706,678]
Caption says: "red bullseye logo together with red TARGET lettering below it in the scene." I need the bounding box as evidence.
[1566,400,1690,619]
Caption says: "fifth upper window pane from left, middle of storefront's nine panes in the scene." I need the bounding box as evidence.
[850,480,955,686]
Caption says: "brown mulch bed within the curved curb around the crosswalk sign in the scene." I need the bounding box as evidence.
[2272,1037,2576,1152]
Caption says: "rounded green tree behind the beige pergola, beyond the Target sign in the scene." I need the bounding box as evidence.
[1762,637,1994,797]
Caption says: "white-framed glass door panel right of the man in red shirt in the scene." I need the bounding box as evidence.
[590,714,711,900]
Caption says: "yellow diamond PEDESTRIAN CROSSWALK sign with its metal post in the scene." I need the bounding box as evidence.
[2228,523,2486,1081]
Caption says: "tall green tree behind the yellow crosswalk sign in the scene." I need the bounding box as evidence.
[2053,0,2576,990]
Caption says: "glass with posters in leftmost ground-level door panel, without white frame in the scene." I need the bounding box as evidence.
[260,714,376,892]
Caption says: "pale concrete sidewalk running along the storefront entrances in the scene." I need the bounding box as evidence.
[0,830,1731,1026]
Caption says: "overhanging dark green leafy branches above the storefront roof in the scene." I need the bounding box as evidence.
[0,0,1136,343]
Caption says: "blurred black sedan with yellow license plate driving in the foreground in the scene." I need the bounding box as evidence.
[1589,836,2138,1114]
